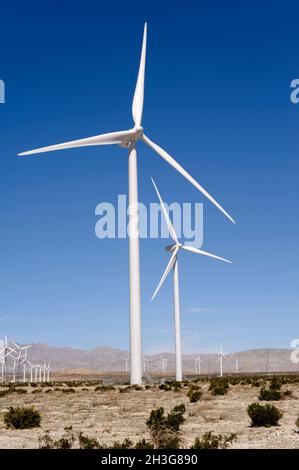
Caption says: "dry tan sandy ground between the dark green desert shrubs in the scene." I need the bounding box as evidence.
[0,384,299,449]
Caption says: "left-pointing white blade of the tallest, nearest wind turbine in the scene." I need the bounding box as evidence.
[18,129,135,156]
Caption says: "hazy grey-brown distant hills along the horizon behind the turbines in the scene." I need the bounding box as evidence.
[28,344,299,374]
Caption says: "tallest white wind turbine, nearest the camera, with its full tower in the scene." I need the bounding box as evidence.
[19,23,234,384]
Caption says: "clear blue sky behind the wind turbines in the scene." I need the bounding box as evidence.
[0,0,299,352]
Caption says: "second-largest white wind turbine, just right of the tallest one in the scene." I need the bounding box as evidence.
[152,178,231,381]
